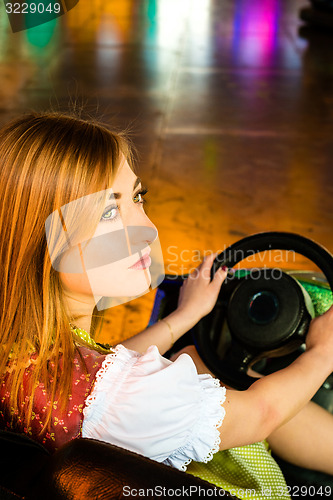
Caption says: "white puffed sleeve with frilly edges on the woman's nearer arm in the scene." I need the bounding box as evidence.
[82,344,225,471]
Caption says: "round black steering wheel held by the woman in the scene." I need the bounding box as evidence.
[192,232,333,390]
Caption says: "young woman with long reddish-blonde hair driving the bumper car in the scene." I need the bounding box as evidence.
[0,113,333,498]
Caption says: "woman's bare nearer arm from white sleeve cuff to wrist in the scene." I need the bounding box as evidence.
[220,347,333,450]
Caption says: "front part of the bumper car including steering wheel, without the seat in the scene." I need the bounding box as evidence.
[149,232,333,488]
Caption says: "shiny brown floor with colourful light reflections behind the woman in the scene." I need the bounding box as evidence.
[0,0,333,343]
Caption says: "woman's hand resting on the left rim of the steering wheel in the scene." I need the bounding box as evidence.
[177,253,227,322]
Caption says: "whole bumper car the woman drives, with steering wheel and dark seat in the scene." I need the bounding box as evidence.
[0,232,333,500]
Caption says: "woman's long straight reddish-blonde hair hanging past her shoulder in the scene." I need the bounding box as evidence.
[0,112,131,431]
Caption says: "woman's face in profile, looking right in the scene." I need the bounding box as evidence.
[59,159,157,303]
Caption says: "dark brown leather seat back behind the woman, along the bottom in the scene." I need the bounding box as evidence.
[0,431,236,500]
